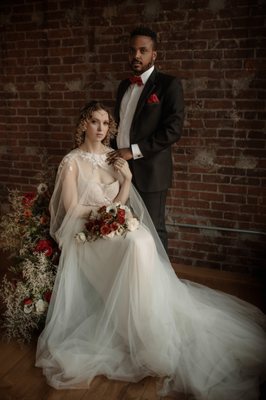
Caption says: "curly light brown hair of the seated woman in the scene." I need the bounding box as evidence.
[75,101,117,147]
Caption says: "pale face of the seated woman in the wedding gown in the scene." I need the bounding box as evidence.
[85,110,109,143]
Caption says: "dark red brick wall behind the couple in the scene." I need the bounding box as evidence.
[0,0,266,274]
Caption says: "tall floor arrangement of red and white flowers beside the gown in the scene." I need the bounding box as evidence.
[0,172,60,342]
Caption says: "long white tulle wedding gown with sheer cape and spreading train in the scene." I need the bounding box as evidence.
[36,149,266,400]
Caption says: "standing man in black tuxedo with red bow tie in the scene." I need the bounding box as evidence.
[109,27,184,250]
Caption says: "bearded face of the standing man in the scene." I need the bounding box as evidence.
[128,36,157,75]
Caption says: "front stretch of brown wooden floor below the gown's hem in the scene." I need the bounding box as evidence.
[0,336,189,400]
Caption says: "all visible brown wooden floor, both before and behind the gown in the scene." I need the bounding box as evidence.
[0,251,266,400]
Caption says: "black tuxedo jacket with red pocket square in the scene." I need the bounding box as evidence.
[114,69,184,192]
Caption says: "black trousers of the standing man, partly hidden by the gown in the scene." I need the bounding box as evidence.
[139,190,168,251]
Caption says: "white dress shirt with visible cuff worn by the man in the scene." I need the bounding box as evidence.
[117,66,154,159]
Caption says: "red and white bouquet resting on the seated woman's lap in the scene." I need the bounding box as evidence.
[75,203,139,243]
